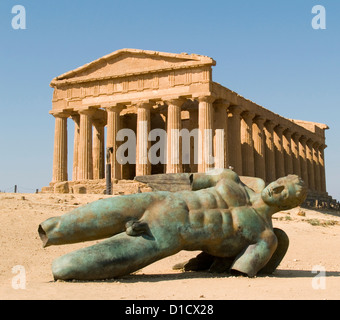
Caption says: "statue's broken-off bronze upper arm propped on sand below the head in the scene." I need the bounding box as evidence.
[231,231,278,277]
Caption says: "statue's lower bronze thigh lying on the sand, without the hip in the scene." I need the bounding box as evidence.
[52,223,180,280]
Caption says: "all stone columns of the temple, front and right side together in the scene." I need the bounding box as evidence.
[53,96,326,192]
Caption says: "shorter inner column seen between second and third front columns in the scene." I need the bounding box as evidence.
[92,120,105,179]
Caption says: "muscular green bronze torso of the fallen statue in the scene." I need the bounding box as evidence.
[145,174,269,257]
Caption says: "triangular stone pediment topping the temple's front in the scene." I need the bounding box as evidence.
[51,49,216,85]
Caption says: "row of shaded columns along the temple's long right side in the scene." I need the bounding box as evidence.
[228,106,326,193]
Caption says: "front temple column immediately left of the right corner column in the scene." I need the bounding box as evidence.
[166,99,183,173]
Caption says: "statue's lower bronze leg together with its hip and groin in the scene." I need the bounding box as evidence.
[52,203,186,280]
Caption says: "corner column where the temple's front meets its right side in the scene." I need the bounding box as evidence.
[198,96,214,172]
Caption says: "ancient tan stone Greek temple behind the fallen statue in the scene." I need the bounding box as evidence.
[50,49,328,193]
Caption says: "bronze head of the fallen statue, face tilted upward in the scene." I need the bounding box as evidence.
[261,175,307,210]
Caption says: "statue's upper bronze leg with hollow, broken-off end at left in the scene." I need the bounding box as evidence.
[38,193,162,247]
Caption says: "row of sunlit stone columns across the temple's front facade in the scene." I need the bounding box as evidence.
[52,97,223,182]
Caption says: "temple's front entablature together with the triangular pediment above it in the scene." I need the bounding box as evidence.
[51,49,216,110]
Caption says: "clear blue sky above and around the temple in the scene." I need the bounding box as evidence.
[0,0,340,200]
